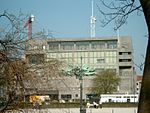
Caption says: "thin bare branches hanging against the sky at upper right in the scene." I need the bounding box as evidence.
[98,0,142,30]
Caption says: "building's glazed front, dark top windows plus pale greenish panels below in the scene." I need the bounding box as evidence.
[47,40,118,73]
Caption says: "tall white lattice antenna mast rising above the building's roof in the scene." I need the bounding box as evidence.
[91,0,96,38]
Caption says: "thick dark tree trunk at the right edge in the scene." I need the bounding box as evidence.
[138,0,150,113]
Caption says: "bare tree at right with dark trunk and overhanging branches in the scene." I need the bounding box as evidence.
[99,0,150,113]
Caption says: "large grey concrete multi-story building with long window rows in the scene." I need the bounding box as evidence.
[26,36,135,99]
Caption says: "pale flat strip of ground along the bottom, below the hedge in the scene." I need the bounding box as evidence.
[6,108,137,113]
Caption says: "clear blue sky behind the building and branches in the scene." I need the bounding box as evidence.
[0,0,147,74]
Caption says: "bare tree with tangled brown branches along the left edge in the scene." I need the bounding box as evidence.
[0,11,52,111]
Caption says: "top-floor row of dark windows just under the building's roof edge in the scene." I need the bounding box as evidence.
[49,41,117,50]
